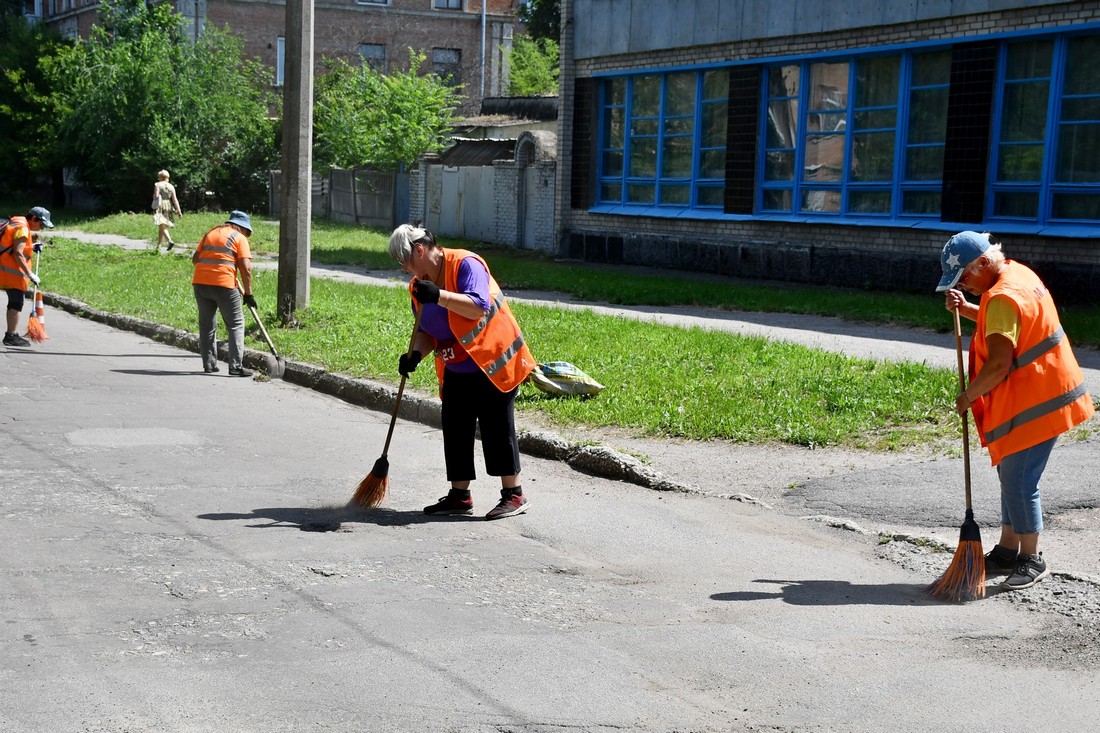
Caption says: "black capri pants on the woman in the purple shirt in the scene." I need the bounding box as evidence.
[441,370,519,481]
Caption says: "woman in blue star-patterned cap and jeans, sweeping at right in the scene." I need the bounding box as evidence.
[936,231,1093,590]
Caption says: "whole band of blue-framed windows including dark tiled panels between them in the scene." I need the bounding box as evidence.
[595,30,1100,233]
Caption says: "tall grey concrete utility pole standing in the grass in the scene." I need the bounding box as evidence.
[278,0,314,326]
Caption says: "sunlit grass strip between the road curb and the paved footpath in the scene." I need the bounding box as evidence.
[45,240,958,450]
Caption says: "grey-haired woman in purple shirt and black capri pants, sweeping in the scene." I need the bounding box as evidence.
[389,225,535,519]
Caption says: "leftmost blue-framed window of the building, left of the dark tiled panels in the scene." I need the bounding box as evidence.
[597,69,729,210]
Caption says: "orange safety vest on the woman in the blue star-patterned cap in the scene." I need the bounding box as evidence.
[970,260,1095,466]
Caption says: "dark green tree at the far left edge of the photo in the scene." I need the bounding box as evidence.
[0,4,64,200]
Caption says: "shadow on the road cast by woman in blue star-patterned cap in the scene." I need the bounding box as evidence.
[711,579,941,605]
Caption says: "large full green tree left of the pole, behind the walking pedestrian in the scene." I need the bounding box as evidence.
[48,0,277,209]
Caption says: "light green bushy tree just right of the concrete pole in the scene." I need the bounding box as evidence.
[314,50,460,171]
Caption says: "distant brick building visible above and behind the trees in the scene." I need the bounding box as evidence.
[34,0,520,114]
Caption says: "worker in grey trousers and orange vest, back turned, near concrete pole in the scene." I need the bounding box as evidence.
[191,211,256,376]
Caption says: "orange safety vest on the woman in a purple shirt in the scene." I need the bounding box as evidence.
[409,249,535,392]
